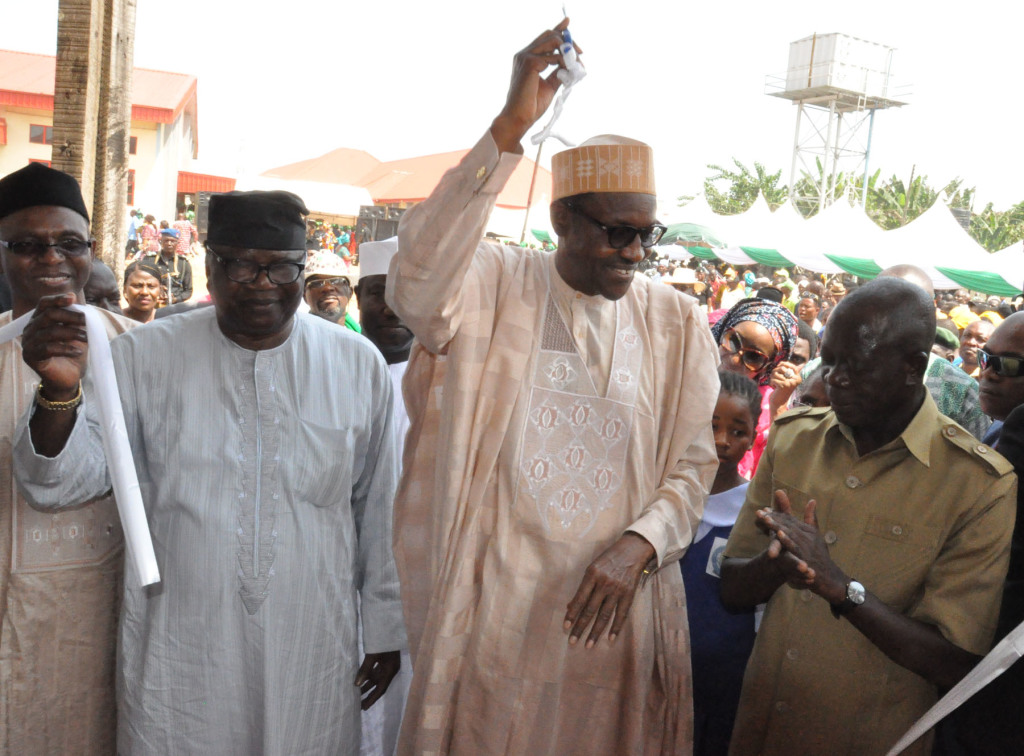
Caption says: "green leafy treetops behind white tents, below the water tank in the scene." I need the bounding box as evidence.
[679,158,1024,252]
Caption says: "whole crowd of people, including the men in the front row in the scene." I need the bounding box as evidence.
[0,19,1024,756]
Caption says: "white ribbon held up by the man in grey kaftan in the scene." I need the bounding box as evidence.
[0,304,160,585]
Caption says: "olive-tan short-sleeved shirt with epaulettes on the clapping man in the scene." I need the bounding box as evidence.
[725,393,1017,756]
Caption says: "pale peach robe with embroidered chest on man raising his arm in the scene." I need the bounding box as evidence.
[387,134,719,756]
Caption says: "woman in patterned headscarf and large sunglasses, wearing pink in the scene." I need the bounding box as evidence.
[711,297,800,477]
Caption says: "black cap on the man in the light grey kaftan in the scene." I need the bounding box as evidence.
[206,192,309,250]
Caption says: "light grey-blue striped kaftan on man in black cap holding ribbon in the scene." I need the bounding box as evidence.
[14,307,406,756]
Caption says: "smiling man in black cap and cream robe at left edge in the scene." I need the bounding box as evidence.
[0,163,138,756]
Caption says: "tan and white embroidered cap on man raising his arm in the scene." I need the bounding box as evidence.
[551,134,656,200]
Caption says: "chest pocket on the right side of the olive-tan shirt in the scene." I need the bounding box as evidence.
[852,514,942,610]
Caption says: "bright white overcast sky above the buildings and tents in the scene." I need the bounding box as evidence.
[0,0,1024,211]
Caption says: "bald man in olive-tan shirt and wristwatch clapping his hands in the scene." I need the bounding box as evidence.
[722,279,1016,756]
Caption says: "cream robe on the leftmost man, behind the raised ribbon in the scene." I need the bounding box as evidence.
[0,309,139,756]
